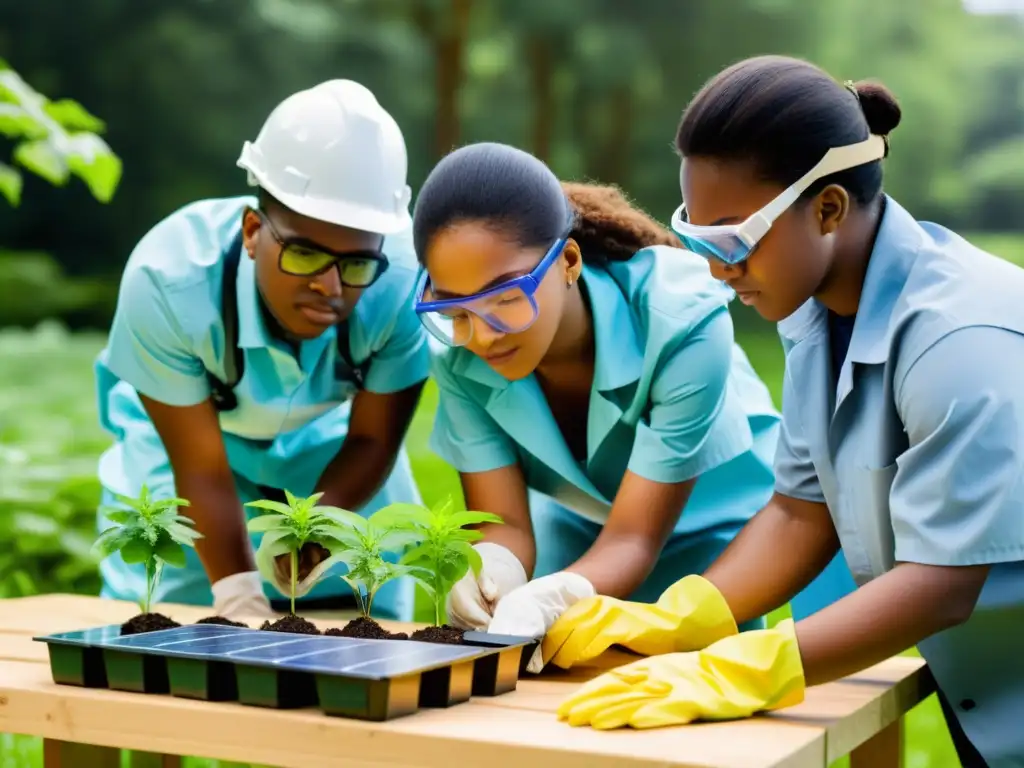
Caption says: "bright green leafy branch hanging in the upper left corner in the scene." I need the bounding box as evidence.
[0,59,122,206]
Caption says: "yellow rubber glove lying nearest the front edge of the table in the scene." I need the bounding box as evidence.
[558,618,805,729]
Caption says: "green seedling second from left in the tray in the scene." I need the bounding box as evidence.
[246,489,346,614]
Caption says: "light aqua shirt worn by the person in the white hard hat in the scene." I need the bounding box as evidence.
[95,197,429,618]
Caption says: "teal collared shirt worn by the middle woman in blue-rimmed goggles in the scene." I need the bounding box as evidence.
[431,247,779,534]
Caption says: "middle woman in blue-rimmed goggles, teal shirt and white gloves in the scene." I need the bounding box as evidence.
[414,143,847,670]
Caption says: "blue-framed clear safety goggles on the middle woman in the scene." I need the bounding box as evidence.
[416,233,568,347]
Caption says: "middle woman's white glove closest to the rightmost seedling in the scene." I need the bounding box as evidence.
[446,542,527,631]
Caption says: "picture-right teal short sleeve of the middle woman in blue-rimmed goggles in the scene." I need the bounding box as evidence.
[629,308,753,483]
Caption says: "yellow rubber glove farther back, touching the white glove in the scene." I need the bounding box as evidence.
[542,575,738,670]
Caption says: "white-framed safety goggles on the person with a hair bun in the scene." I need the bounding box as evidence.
[672,135,888,264]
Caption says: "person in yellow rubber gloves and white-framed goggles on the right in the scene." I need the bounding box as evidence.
[546,56,1024,768]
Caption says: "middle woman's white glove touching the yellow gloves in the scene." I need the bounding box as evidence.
[487,570,597,675]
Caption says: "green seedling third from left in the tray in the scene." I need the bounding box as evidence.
[325,504,425,617]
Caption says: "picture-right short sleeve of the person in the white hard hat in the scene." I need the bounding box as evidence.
[367,274,430,393]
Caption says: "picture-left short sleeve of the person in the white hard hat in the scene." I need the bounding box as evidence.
[103,262,210,406]
